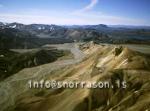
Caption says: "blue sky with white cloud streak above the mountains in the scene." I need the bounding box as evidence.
[0,0,150,26]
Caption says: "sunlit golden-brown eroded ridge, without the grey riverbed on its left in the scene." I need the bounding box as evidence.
[2,43,150,111]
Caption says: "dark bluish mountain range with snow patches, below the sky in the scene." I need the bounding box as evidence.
[0,22,150,49]
